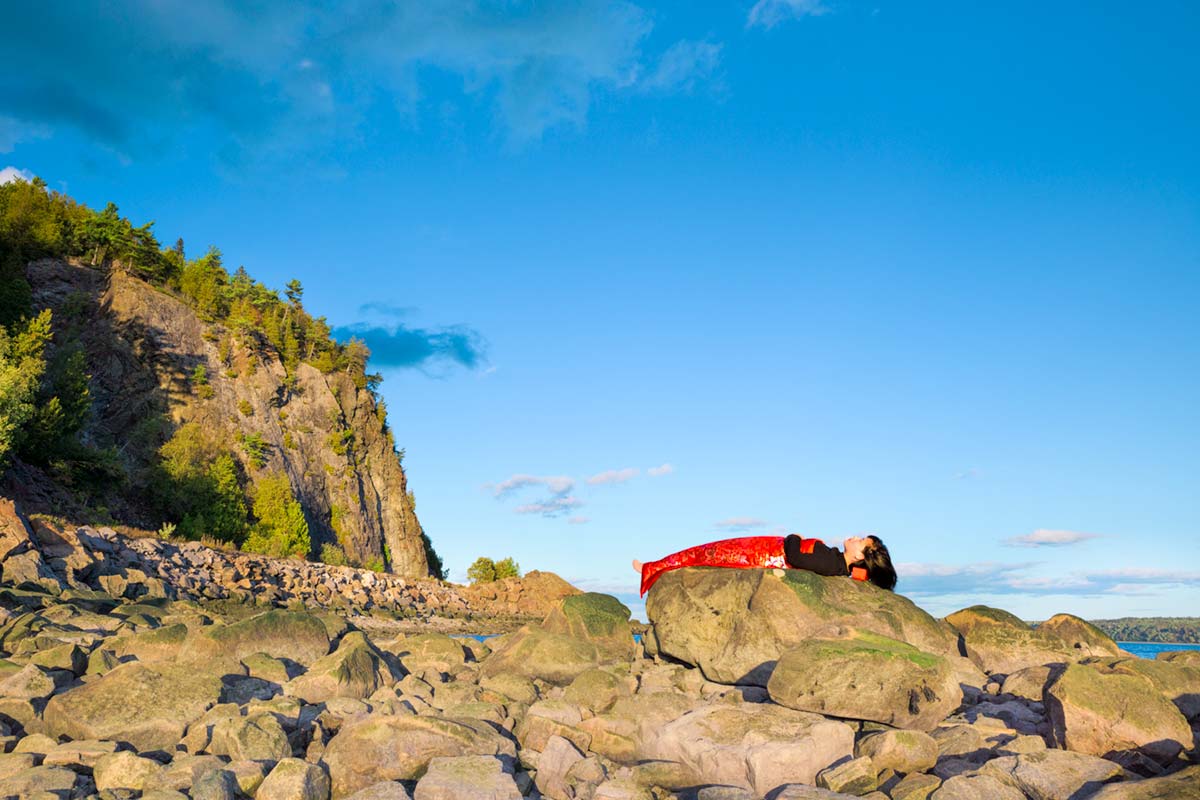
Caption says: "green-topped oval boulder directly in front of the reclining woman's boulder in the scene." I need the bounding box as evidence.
[767,632,962,730]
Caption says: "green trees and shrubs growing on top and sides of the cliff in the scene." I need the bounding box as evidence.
[0,179,444,577]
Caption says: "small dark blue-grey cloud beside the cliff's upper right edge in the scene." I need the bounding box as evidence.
[332,323,486,369]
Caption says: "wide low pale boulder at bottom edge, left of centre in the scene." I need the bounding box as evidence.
[324,714,516,800]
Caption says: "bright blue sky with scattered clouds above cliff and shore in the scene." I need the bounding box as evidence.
[0,0,1200,619]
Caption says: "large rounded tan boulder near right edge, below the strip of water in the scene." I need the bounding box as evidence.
[1044,661,1193,764]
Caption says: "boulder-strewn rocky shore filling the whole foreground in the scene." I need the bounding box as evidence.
[0,496,1200,800]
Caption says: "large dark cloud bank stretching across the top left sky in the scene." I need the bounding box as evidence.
[0,0,720,159]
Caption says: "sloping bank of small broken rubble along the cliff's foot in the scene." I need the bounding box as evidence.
[0,498,578,633]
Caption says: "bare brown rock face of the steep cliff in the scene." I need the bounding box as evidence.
[25,260,430,577]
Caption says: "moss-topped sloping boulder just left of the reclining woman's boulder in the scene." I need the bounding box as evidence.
[480,593,634,686]
